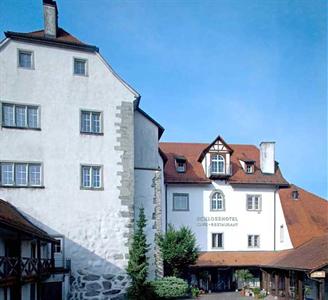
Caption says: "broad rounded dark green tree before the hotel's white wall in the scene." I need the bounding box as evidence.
[157,225,198,278]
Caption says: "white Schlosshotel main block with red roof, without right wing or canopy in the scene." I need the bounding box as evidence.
[161,137,292,251]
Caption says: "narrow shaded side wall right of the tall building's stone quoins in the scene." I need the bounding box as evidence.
[134,111,163,279]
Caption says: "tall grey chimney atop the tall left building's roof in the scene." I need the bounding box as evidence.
[43,0,58,38]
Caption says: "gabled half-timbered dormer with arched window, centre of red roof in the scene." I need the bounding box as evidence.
[198,136,233,179]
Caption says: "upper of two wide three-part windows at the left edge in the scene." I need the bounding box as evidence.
[1,103,40,129]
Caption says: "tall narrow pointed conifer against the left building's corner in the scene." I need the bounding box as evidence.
[127,208,149,300]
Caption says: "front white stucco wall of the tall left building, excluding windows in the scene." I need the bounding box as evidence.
[0,41,135,282]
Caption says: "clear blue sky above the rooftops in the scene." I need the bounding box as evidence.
[0,0,328,198]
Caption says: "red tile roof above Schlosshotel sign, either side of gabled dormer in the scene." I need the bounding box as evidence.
[160,143,288,186]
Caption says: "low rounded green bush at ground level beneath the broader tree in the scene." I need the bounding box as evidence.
[151,277,188,299]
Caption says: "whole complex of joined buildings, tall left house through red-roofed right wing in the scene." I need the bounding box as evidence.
[0,0,328,300]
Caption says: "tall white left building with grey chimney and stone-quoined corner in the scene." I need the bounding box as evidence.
[0,0,163,300]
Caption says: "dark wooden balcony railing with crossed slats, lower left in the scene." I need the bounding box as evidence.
[0,256,54,281]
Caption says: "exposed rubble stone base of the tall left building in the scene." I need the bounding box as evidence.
[68,270,130,300]
